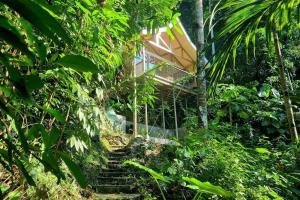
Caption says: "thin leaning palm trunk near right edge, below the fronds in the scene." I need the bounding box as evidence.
[273,23,298,143]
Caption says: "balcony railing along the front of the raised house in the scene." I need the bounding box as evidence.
[136,51,196,88]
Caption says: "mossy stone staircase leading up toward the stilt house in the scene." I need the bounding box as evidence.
[92,145,141,200]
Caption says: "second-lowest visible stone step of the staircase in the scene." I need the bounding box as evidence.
[92,184,136,193]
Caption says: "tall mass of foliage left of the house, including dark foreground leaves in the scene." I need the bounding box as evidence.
[0,0,180,198]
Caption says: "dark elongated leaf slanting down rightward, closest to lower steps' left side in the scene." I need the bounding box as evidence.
[57,152,87,188]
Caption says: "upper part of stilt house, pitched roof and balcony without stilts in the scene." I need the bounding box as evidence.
[135,20,197,93]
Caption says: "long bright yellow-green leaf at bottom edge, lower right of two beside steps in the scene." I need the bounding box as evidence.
[182,177,232,197]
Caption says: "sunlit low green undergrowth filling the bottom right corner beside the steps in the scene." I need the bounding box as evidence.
[148,129,299,199]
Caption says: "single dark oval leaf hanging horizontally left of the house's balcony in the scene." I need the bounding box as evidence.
[56,55,99,73]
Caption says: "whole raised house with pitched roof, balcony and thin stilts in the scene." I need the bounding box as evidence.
[133,19,197,138]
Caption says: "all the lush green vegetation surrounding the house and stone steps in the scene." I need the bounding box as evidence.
[0,0,300,199]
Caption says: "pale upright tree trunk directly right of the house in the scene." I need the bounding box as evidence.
[195,0,208,128]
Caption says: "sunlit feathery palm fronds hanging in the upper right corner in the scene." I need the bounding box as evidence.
[208,0,299,84]
